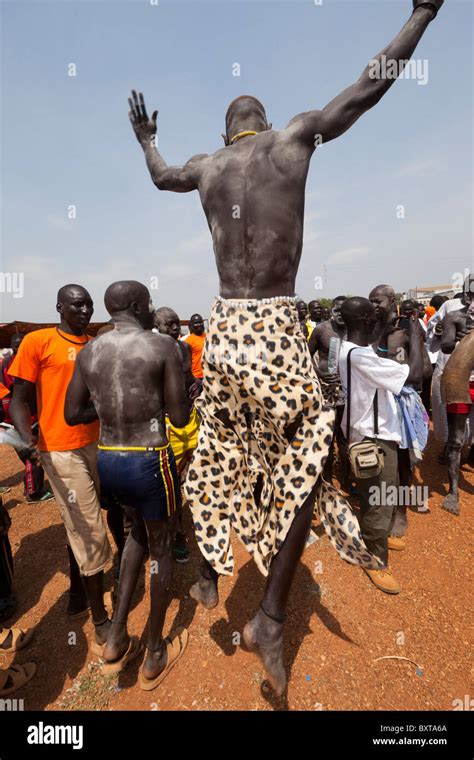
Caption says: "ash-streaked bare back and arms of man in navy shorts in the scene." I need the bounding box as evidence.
[66,296,189,447]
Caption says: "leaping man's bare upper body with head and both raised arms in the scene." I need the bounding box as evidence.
[129,0,443,298]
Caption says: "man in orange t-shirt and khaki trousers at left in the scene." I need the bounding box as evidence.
[9,285,111,644]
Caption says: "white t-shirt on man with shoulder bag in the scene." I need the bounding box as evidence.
[339,340,410,443]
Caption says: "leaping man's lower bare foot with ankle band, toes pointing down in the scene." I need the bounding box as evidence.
[244,609,287,697]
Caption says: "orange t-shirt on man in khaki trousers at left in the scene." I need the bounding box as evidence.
[8,327,99,451]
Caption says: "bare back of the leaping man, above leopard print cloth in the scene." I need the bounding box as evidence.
[199,130,314,298]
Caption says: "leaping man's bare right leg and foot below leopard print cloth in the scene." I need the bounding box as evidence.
[244,484,318,696]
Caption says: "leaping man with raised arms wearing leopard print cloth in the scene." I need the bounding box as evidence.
[129,0,442,694]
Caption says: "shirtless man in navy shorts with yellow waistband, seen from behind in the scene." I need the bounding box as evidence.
[65,281,189,690]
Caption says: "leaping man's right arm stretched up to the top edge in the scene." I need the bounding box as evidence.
[287,0,444,145]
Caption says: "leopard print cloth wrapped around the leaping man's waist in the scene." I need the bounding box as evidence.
[185,298,380,576]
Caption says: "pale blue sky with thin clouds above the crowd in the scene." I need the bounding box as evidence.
[0,0,473,321]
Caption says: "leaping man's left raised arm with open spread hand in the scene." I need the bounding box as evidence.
[128,90,204,193]
